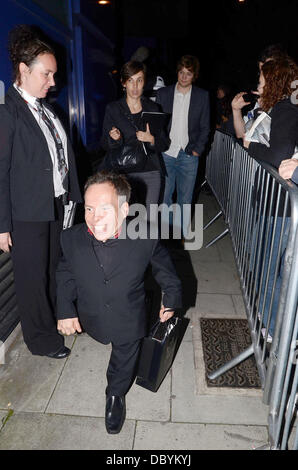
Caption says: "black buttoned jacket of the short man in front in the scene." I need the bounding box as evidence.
[56,224,181,344]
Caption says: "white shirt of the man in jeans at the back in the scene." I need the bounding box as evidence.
[166,84,192,158]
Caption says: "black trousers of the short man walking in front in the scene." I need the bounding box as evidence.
[106,339,142,396]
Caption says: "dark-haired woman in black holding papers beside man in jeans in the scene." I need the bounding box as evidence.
[101,61,169,208]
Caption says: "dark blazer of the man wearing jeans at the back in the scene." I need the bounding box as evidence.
[156,85,210,155]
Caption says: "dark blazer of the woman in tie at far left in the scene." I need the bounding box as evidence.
[0,87,81,233]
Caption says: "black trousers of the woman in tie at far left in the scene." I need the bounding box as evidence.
[11,199,64,355]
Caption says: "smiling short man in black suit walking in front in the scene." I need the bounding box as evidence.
[56,172,181,434]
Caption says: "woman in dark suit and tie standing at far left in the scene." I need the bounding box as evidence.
[0,25,81,359]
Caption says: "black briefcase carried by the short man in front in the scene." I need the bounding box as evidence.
[136,317,189,392]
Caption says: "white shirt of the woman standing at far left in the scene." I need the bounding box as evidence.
[14,84,68,197]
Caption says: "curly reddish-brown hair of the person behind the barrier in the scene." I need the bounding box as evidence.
[261,57,298,112]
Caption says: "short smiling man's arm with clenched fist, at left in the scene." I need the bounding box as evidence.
[56,232,82,335]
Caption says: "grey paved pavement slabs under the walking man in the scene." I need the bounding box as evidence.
[0,193,268,451]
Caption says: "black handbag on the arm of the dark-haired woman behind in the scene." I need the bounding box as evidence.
[108,112,147,172]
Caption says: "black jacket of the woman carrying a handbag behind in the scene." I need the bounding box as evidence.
[101,97,170,171]
